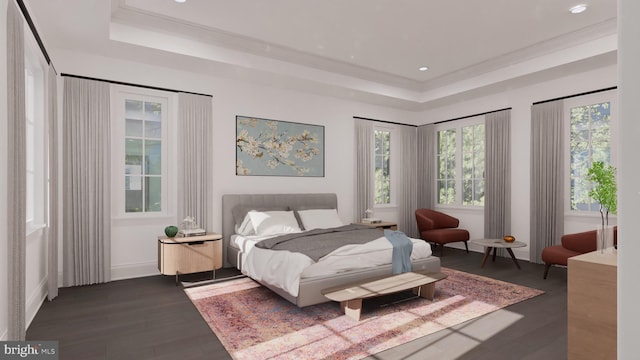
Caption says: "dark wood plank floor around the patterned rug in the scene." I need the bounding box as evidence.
[27,248,567,360]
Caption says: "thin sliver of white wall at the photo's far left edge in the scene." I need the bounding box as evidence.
[0,0,9,340]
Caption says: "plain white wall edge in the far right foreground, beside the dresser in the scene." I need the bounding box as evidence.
[618,0,640,359]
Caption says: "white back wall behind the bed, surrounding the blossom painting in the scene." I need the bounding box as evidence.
[52,47,419,279]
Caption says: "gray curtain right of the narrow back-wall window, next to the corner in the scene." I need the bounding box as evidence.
[392,126,418,237]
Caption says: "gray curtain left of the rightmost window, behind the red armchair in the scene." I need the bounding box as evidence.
[529,100,564,263]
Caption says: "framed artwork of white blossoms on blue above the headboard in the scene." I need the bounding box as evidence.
[236,116,324,177]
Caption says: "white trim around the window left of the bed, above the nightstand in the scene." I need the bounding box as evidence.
[111,85,177,220]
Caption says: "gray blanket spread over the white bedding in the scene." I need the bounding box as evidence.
[256,224,384,261]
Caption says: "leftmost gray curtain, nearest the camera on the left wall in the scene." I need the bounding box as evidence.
[5,1,27,341]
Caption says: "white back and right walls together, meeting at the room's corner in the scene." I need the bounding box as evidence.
[47,45,617,279]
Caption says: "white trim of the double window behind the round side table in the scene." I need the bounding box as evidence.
[434,115,486,211]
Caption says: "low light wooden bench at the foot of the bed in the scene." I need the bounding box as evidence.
[322,272,447,321]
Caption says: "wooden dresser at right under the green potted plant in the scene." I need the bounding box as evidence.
[567,251,618,360]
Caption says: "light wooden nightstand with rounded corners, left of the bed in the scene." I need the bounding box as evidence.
[158,233,222,285]
